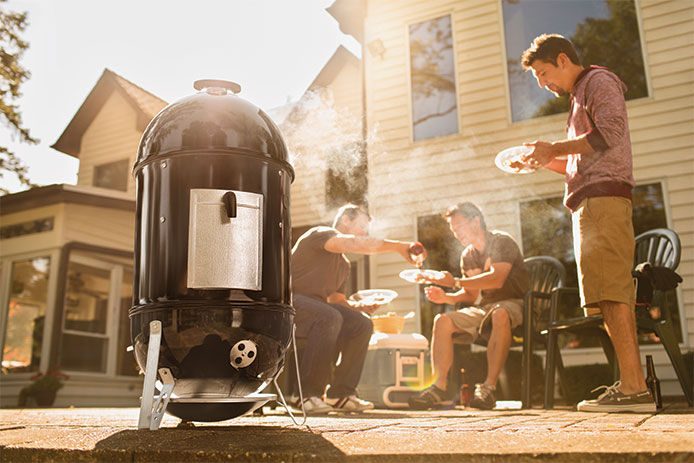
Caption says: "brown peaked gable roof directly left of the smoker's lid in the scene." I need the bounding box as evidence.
[51,69,167,158]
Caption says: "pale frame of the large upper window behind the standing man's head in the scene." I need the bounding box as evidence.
[500,0,654,127]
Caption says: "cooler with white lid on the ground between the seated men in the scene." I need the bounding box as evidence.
[357,333,429,408]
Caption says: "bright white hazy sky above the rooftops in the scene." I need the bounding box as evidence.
[0,0,359,192]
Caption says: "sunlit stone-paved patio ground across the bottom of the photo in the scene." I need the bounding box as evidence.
[0,404,694,463]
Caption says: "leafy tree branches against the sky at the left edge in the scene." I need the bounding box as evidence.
[0,0,39,193]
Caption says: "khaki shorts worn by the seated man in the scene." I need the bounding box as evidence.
[444,299,523,344]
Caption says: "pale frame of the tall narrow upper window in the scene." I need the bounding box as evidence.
[404,8,462,145]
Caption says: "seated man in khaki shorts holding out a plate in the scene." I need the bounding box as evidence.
[409,202,530,410]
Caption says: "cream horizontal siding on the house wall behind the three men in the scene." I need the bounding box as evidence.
[365,0,694,392]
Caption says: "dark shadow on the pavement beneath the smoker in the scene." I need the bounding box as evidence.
[94,425,344,461]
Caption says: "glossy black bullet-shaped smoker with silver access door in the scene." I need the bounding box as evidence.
[130,80,294,421]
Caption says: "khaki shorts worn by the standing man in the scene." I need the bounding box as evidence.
[571,196,635,307]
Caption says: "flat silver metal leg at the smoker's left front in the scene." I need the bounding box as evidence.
[137,320,174,430]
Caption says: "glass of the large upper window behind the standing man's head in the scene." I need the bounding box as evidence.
[502,0,648,122]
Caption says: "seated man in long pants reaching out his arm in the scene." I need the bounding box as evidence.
[292,204,426,414]
